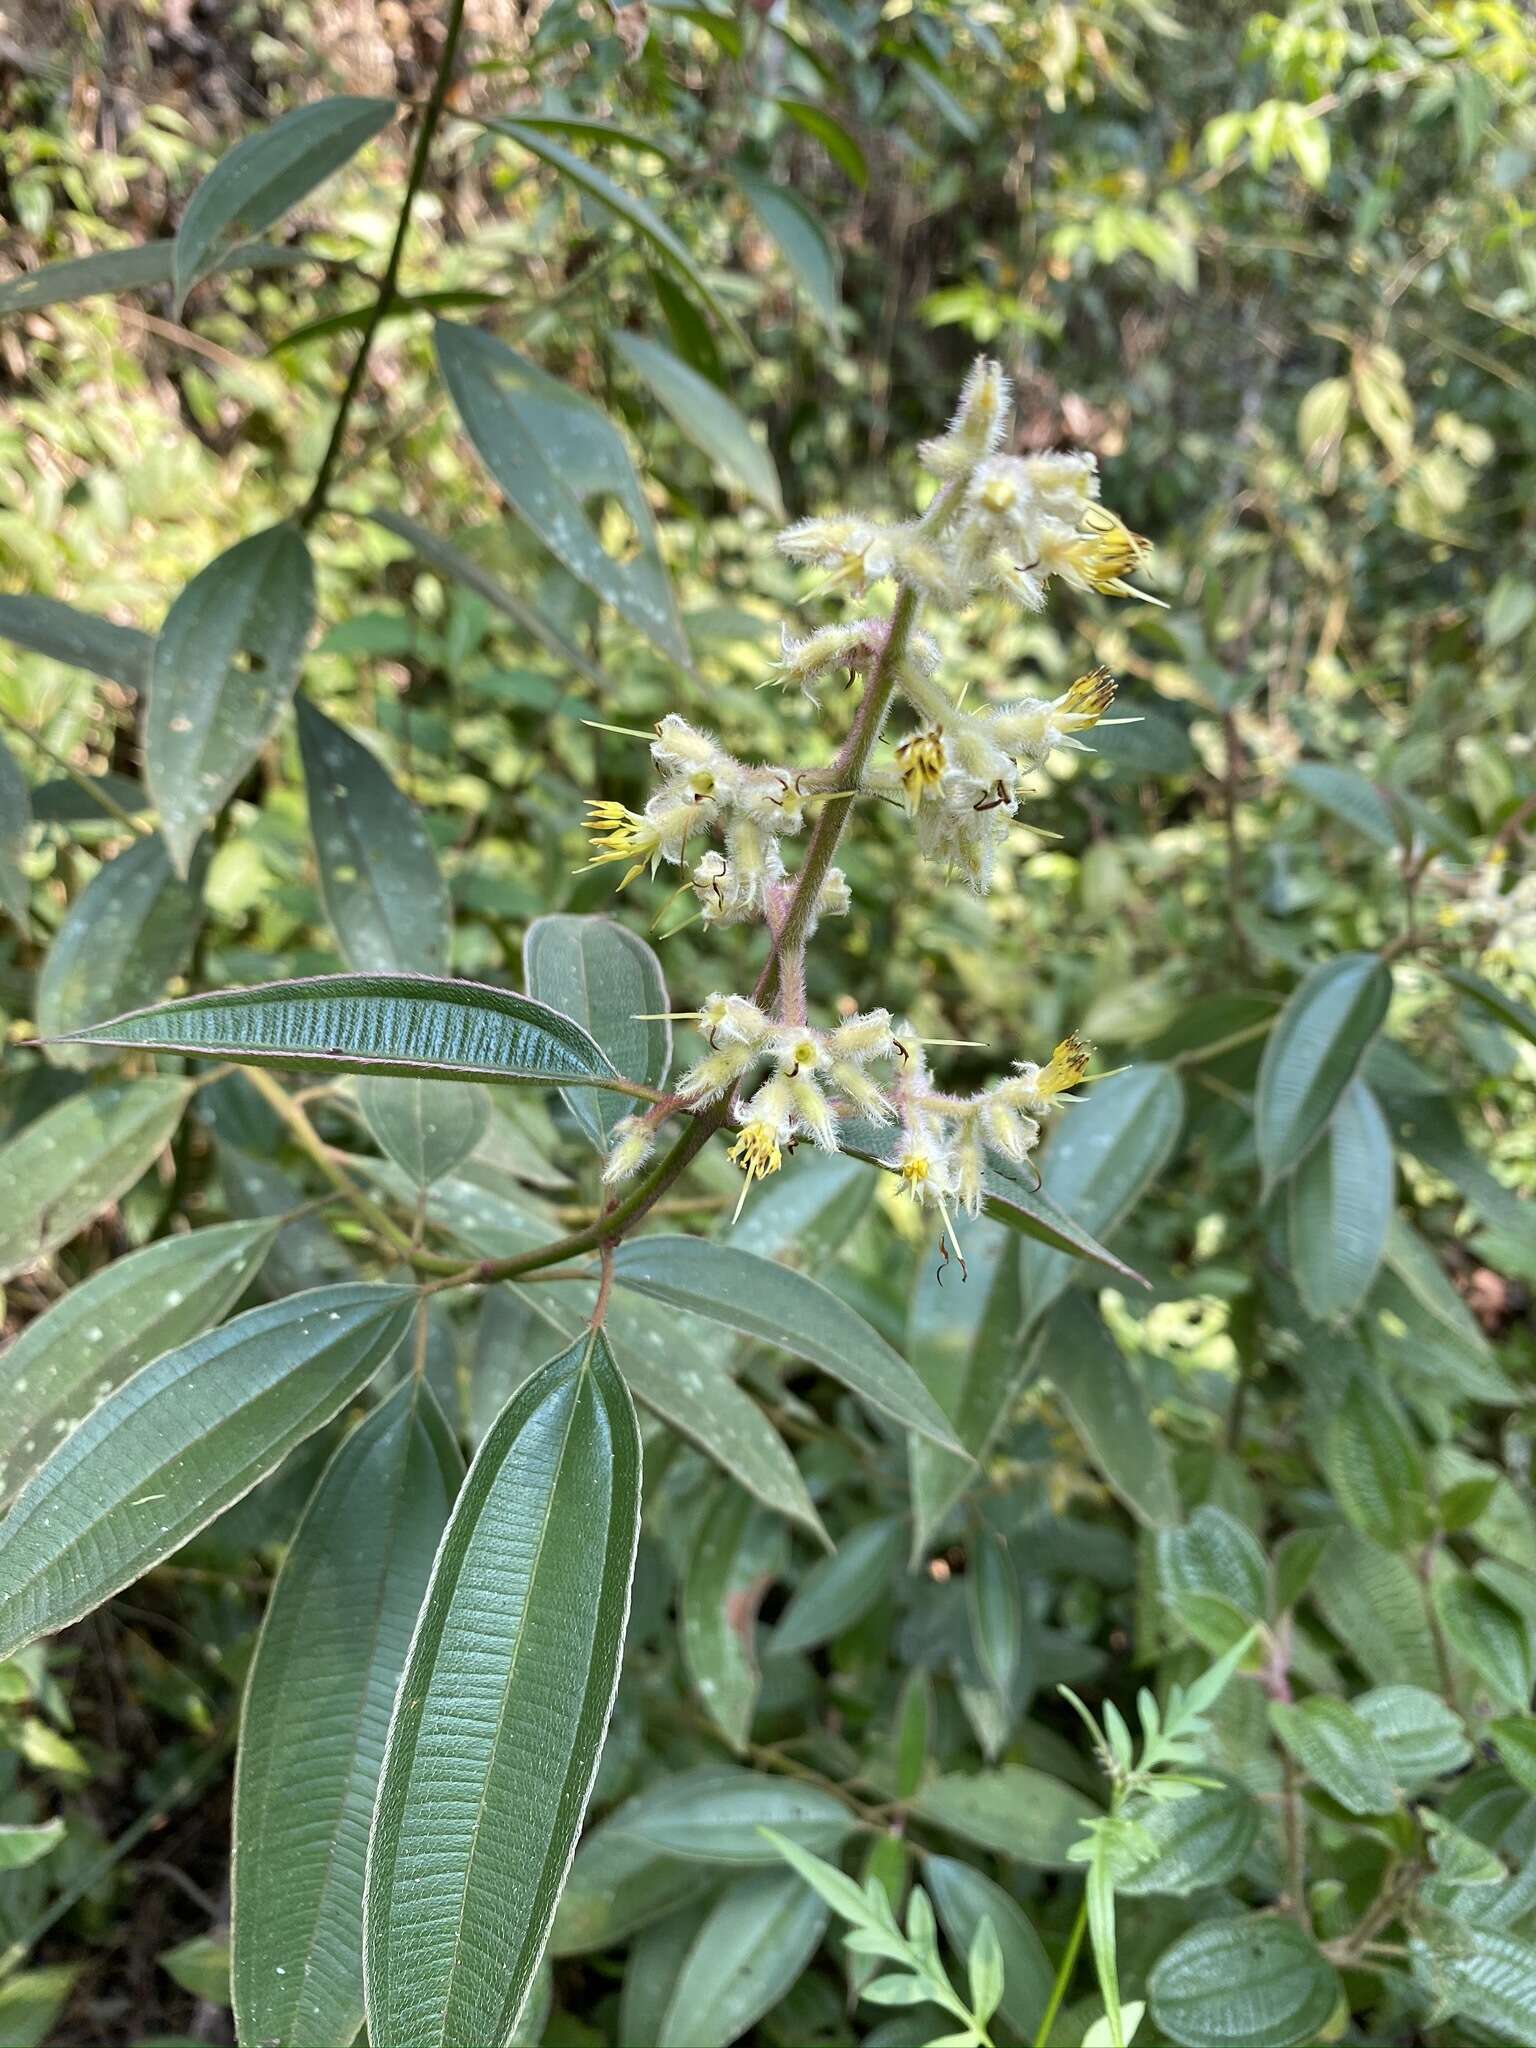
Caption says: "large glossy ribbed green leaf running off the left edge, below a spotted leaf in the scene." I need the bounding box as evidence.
[0,1277,416,1657]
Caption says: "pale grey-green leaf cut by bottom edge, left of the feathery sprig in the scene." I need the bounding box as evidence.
[657,1870,827,2048]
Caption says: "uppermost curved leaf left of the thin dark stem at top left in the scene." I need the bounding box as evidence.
[174,98,397,319]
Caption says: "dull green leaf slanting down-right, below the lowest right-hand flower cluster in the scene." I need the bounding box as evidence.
[1036,1298,1180,1528]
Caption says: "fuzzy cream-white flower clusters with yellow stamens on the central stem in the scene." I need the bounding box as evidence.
[588,358,1159,1255]
